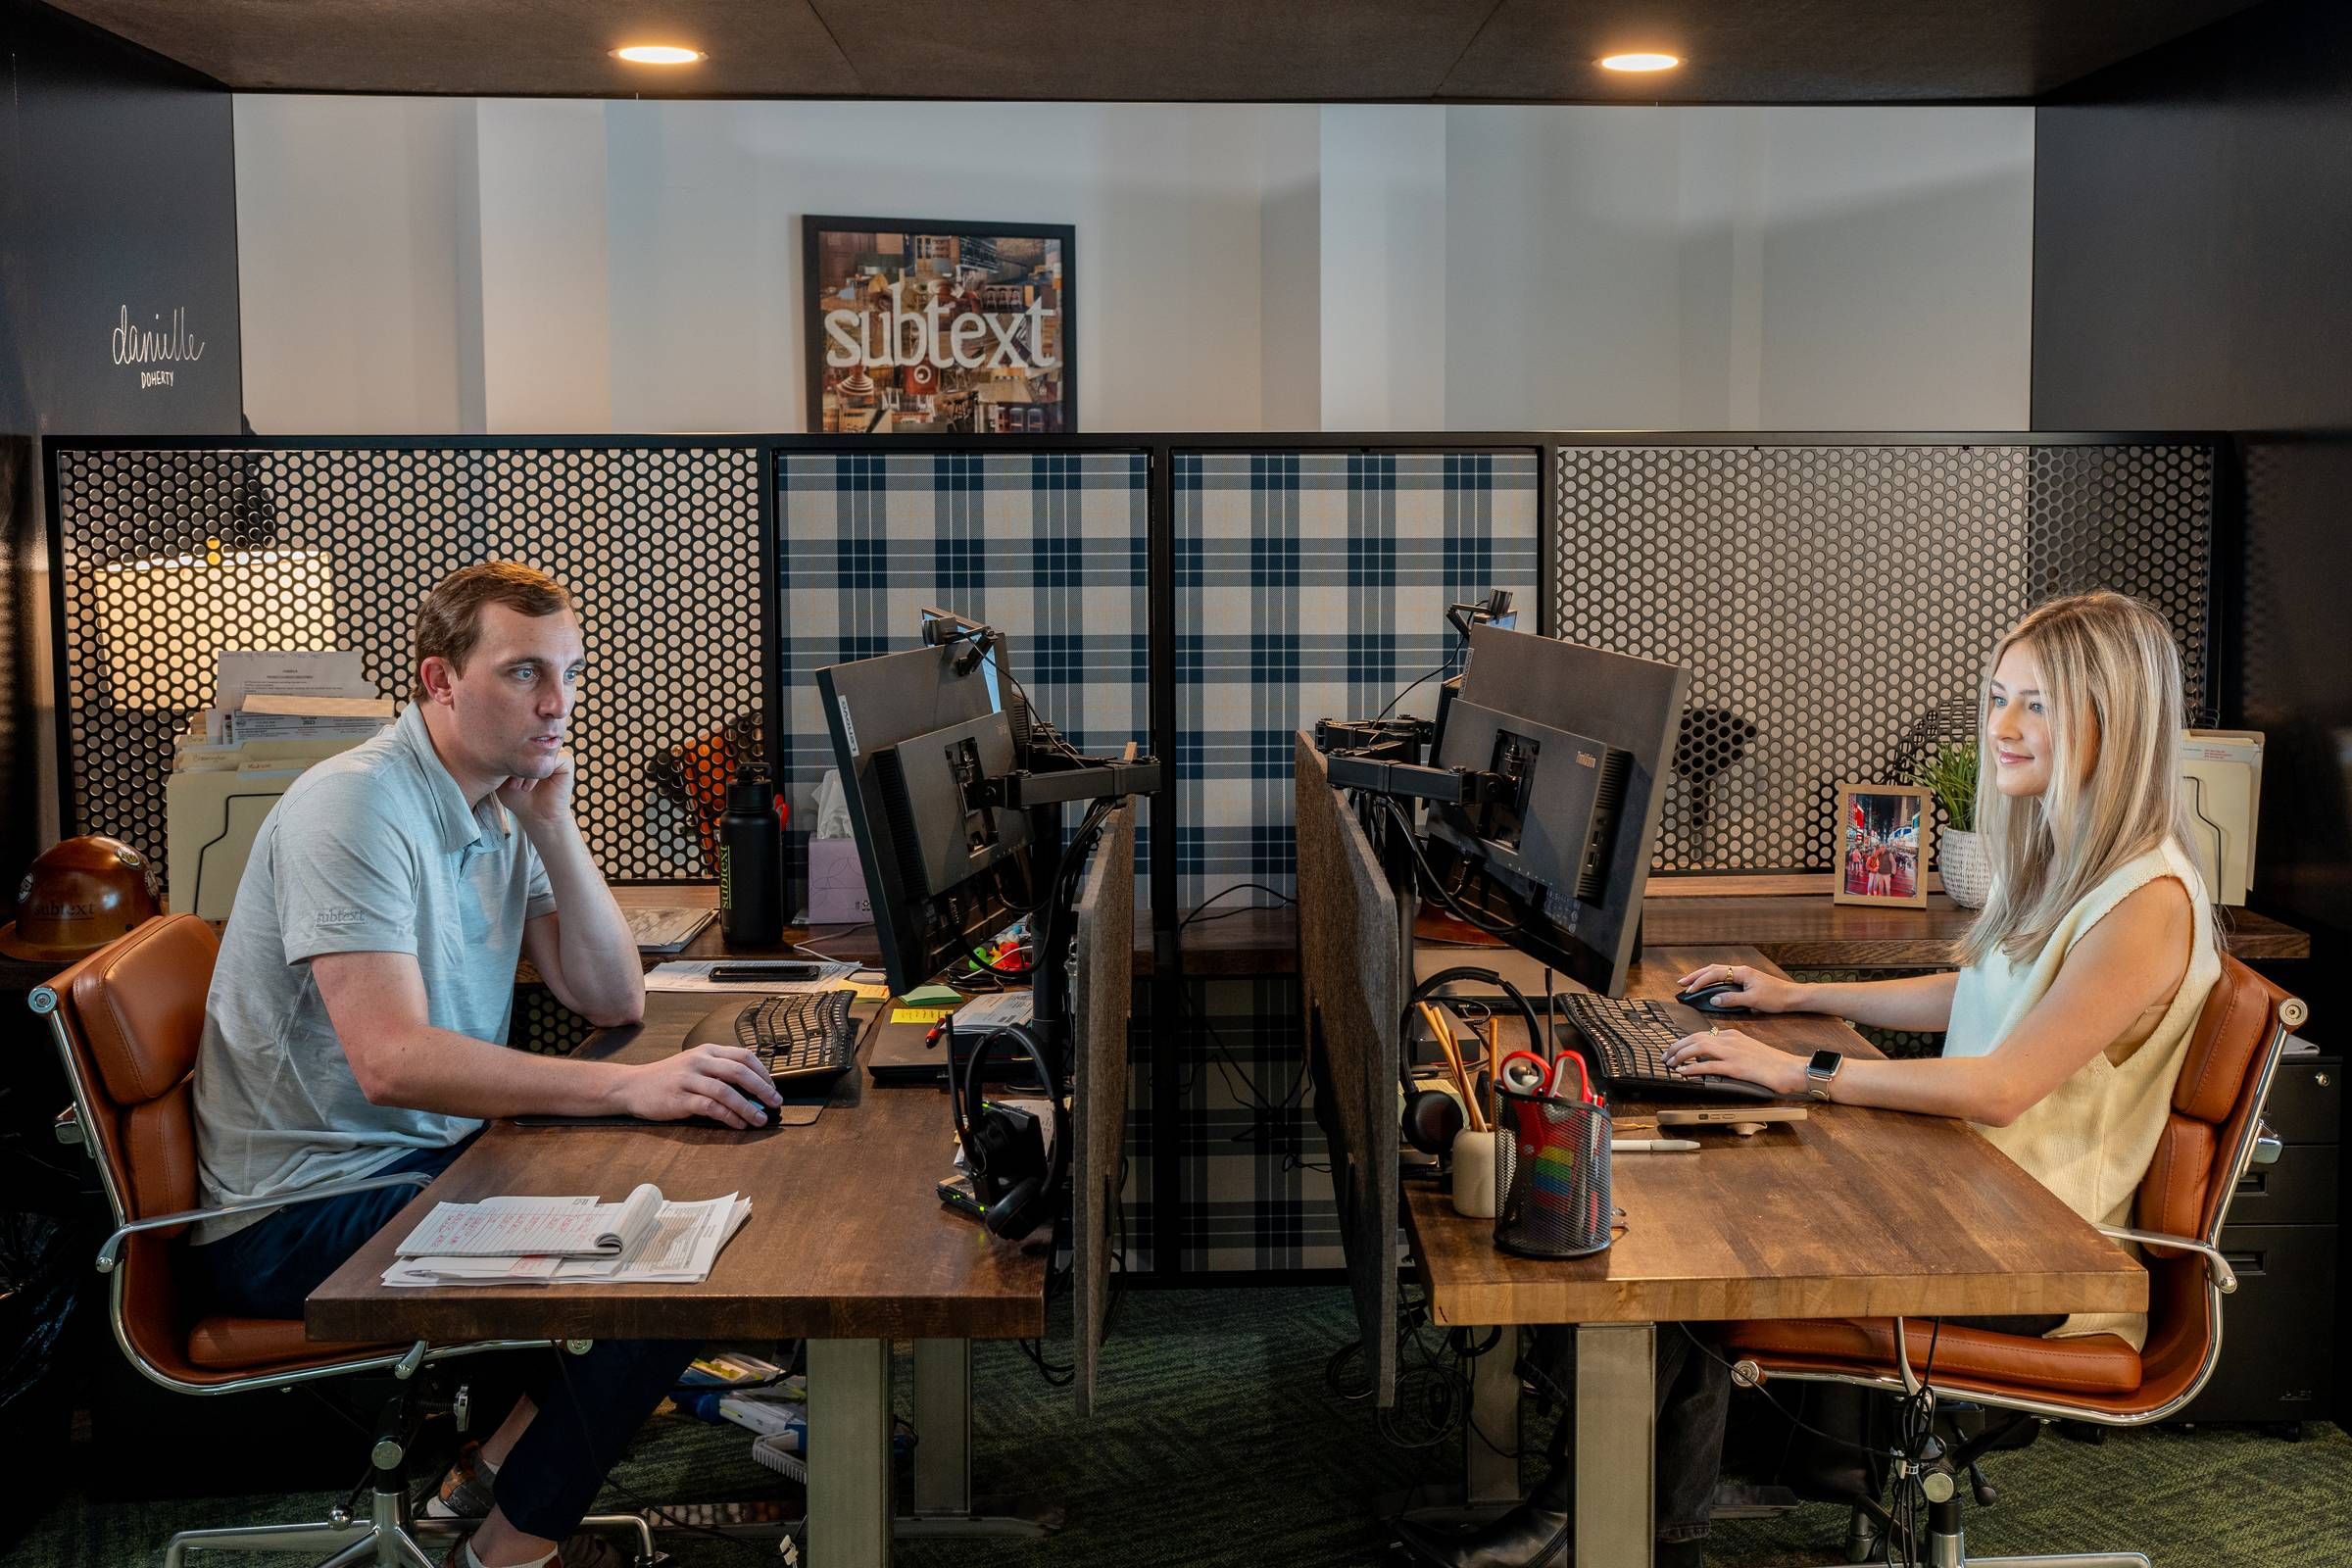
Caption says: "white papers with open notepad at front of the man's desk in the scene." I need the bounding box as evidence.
[383,1183,751,1286]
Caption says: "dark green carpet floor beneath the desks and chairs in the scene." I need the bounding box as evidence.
[7,1289,2352,1568]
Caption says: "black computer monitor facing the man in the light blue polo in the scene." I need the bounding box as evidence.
[816,637,1060,992]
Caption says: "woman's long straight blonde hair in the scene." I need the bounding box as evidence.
[1959,592,2192,964]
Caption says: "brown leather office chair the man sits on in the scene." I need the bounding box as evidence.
[30,914,654,1568]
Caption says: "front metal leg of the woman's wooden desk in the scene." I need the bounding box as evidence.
[1576,1324,1658,1568]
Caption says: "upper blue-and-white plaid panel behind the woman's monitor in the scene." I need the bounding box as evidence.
[1174,452,1541,909]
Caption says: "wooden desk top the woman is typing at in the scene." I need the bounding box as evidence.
[1404,948,2147,1326]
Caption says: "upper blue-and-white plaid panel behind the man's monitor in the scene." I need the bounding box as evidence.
[776,452,1151,909]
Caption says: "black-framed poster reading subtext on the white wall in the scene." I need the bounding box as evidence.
[800,217,1077,435]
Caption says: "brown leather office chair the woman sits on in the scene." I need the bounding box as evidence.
[1727,956,2310,1568]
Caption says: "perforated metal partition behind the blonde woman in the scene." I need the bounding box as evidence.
[1547,437,2218,870]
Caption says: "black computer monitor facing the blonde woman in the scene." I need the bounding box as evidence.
[1428,625,1691,997]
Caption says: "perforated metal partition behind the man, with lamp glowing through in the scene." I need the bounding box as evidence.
[52,440,766,882]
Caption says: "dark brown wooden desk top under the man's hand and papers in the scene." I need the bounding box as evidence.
[304,992,1047,1343]
